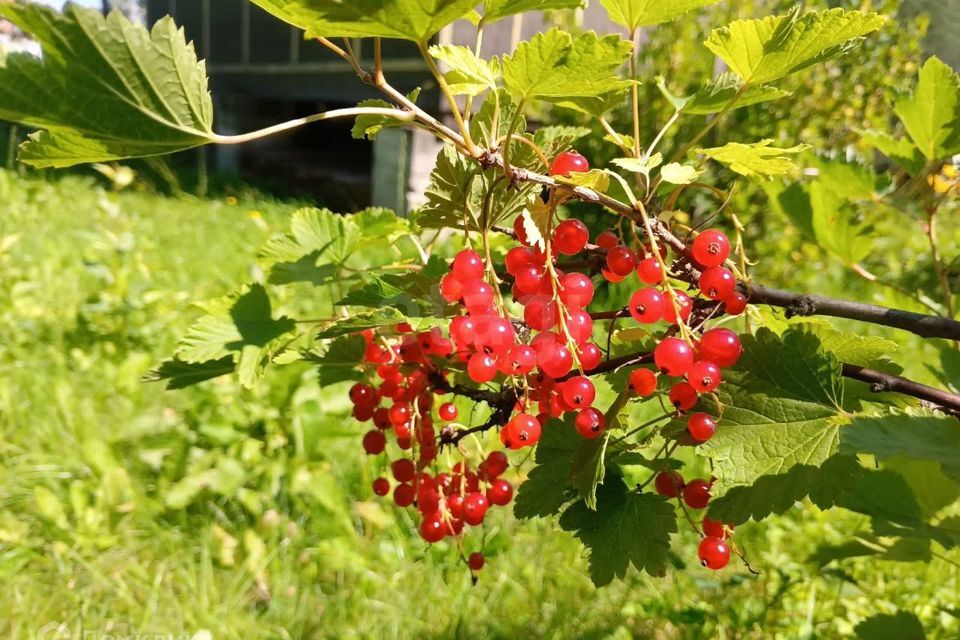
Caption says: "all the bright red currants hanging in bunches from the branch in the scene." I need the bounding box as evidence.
[350,153,746,571]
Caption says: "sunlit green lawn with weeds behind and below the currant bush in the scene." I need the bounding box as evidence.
[0,172,960,639]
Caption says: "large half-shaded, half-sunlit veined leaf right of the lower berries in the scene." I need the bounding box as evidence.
[701,327,847,488]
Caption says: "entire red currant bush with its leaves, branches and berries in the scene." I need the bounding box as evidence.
[0,0,960,632]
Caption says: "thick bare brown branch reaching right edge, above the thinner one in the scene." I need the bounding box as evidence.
[742,284,960,340]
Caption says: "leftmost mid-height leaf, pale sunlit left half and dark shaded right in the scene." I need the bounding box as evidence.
[176,284,296,363]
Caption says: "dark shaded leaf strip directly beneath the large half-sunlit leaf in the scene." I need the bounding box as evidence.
[709,456,861,524]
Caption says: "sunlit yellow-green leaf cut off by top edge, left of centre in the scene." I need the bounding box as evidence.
[251,0,477,43]
